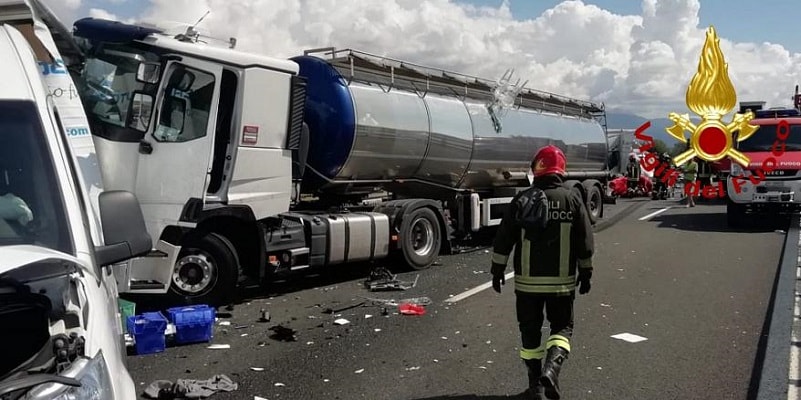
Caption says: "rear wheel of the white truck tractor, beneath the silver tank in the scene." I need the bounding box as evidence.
[400,207,442,270]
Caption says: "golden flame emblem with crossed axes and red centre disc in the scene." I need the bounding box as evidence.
[665,26,759,168]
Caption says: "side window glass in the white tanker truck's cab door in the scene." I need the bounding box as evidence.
[153,64,214,142]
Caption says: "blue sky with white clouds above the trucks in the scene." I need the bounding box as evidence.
[37,0,801,118]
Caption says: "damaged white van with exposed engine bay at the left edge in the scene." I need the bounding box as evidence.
[0,24,152,400]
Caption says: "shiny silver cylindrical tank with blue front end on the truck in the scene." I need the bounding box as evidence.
[292,55,607,192]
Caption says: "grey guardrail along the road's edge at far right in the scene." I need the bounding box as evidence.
[749,213,800,400]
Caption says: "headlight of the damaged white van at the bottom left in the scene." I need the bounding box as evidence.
[29,351,114,400]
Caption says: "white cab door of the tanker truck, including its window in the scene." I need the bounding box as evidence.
[136,57,222,231]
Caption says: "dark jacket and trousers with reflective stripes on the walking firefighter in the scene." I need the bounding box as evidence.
[492,176,594,360]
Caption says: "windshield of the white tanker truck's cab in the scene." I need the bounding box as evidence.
[80,45,159,131]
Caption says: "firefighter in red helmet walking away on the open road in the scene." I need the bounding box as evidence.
[492,146,594,399]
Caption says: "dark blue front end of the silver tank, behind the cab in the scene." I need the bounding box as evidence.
[292,56,356,188]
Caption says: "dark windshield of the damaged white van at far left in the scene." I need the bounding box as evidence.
[0,100,74,254]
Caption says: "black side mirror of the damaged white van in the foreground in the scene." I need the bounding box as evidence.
[95,190,153,266]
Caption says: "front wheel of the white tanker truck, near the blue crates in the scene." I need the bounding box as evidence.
[170,233,239,305]
